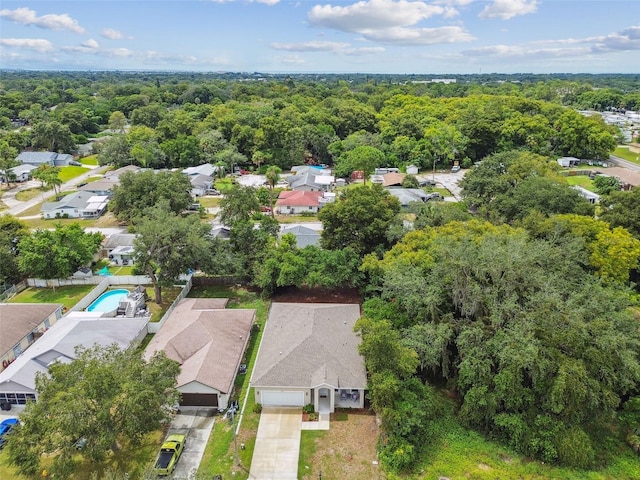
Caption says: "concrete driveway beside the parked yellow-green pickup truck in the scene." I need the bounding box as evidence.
[167,407,216,480]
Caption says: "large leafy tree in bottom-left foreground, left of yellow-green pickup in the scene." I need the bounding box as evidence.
[6,344,180,478]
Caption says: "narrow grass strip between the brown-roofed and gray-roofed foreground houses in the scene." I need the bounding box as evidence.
[189,287,269,480]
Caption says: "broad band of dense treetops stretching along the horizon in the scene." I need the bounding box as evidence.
[0,72,640,174]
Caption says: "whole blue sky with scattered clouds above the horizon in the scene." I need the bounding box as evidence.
[0,0,640,74]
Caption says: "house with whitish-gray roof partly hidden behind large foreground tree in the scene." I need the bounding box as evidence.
[0,312,148,405]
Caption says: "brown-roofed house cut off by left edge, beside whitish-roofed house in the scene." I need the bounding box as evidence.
[0,303,62,376]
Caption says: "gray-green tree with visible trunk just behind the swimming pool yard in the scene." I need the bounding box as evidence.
[134,200,211,304]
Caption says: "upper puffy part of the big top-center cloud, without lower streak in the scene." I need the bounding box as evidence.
[308,0,453,33]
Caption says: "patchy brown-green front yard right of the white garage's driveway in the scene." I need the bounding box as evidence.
[300,413,385,480]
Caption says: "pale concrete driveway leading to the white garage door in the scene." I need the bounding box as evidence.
[249,407,302,480]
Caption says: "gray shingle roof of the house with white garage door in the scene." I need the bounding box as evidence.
[251,302,367,388]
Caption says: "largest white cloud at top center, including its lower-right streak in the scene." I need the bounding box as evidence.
[308,0,474,45]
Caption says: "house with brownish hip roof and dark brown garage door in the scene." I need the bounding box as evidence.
[144,298,256,409]
